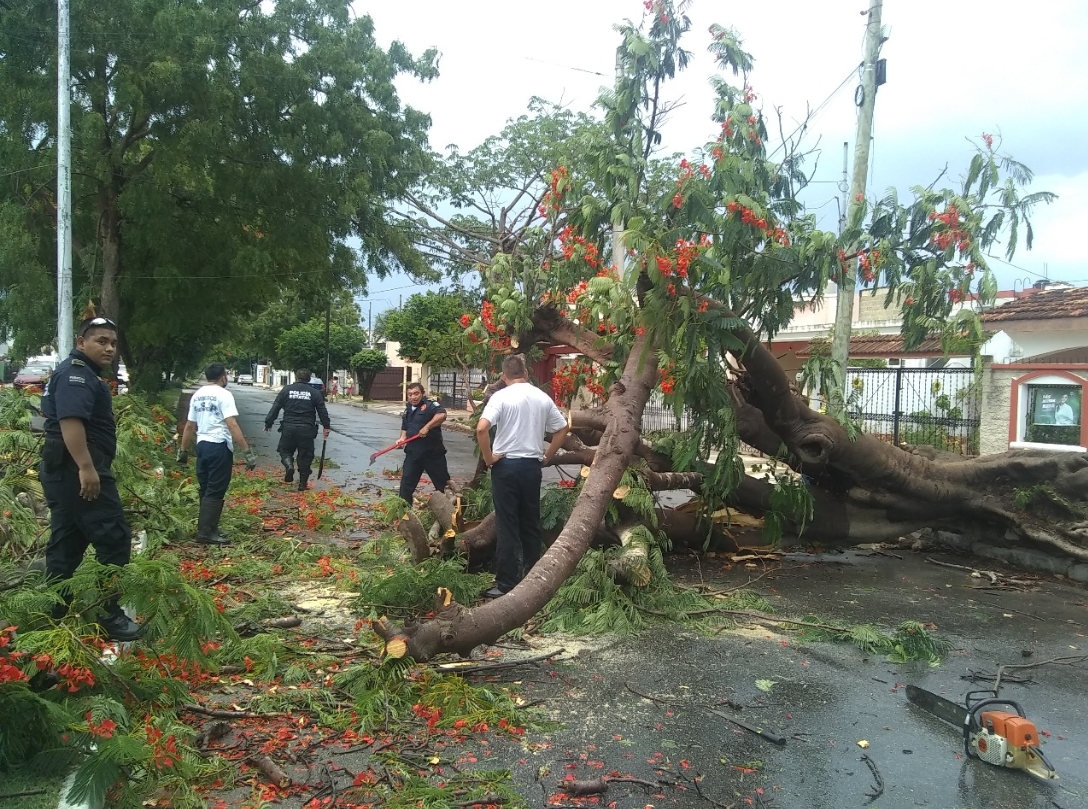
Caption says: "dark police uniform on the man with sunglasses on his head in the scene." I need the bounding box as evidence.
[38,349,132,618]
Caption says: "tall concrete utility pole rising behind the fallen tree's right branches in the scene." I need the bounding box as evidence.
[828,0,883,412]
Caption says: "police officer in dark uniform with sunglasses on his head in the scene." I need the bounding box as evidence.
[39,310,143,642]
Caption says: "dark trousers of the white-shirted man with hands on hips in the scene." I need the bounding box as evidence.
[491,458,544,593]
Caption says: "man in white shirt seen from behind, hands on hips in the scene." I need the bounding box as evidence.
[477,354,569,598]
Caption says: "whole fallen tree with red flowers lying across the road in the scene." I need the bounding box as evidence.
[376,0,1070,660]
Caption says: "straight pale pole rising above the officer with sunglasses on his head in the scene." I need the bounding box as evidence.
[57,0,75,359]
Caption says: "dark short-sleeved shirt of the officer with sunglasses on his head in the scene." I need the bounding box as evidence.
[41,349,118,461]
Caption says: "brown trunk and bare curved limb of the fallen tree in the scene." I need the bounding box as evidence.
[376,302,1088,660]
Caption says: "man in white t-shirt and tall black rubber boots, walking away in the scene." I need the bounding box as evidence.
[177,362,257,545]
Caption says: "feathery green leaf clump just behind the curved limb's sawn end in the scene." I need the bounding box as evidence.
[358,557,489,618]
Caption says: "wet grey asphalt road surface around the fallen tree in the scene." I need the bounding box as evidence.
[233,388,1088,809]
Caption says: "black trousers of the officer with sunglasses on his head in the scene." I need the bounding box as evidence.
[38,461,132,578]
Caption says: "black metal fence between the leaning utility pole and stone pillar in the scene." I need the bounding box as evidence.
[846,366,981,456]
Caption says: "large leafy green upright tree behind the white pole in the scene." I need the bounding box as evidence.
[0,0,435,385]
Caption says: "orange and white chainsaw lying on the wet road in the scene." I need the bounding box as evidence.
[906,685,1058,779]
